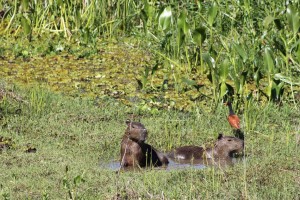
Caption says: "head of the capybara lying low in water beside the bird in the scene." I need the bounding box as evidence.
[215,133,244,156]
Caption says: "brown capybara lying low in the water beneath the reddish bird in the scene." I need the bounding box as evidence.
[168,134,244,161]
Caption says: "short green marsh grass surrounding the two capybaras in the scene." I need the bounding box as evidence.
[0,83,300,199]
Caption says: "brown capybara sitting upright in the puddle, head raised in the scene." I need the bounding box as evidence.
[120,120,169,167]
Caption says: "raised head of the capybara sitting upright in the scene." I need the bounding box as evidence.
[125,119,148,142]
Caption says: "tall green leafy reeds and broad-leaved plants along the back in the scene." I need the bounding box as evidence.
[0,0,300,106]
